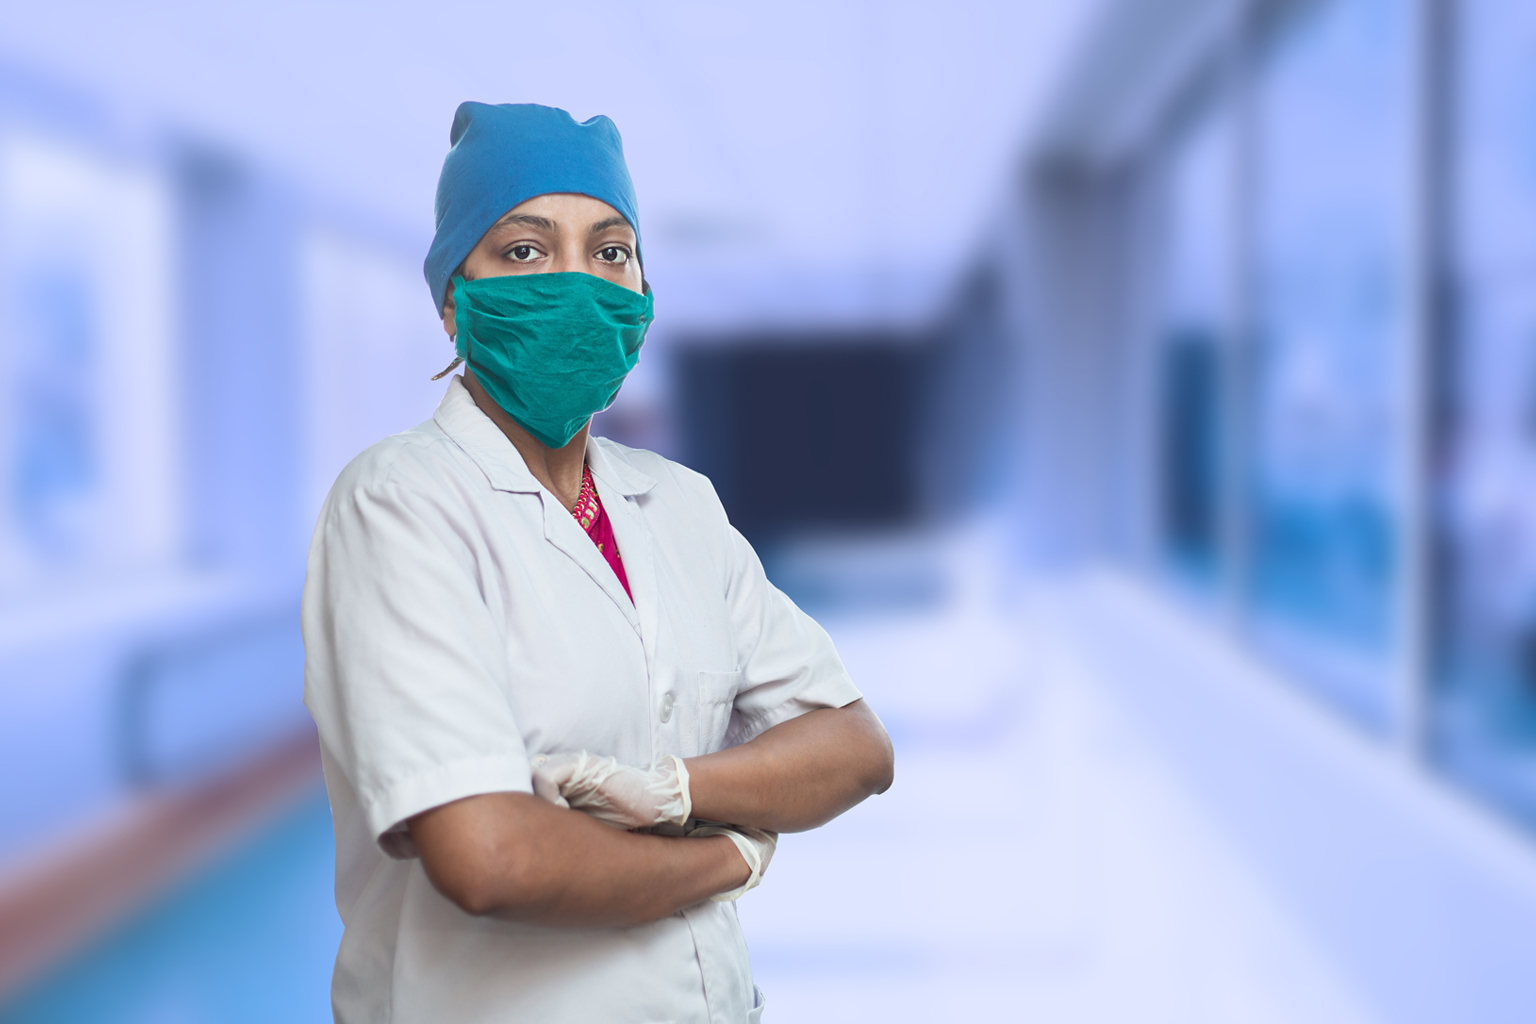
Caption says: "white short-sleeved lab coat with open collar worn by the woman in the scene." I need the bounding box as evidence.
[303,378,859,1024]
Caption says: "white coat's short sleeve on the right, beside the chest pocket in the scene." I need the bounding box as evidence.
[727,525,863,745]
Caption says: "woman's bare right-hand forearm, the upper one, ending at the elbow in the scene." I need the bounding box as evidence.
[685,700,894,832]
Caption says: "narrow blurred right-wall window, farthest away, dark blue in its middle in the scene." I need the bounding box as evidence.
[1157,99,1235,580]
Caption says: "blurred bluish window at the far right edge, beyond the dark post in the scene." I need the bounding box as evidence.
[1435,0,1536,815]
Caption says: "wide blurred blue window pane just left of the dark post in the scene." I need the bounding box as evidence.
[1249,0,1413,726]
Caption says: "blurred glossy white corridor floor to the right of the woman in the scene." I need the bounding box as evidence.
[740,580,1372,1024]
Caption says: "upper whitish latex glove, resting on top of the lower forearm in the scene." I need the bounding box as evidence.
[528,751,693,829]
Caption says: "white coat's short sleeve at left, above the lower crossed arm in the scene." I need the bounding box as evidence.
[303,463,531,857]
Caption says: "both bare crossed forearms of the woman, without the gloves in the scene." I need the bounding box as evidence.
[410,700,894,927]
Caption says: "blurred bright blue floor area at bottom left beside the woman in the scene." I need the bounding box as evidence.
[0,791,341,1024]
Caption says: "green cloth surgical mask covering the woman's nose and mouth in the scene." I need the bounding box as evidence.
[450,273,654,448]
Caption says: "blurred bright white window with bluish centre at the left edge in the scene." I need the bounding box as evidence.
[0,132,178,602]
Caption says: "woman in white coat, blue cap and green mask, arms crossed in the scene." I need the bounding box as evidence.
[303,103,892,1024]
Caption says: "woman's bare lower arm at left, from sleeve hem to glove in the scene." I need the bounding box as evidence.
[409,792,751,927]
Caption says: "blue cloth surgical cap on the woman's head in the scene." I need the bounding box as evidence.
[422,103,641,313]
